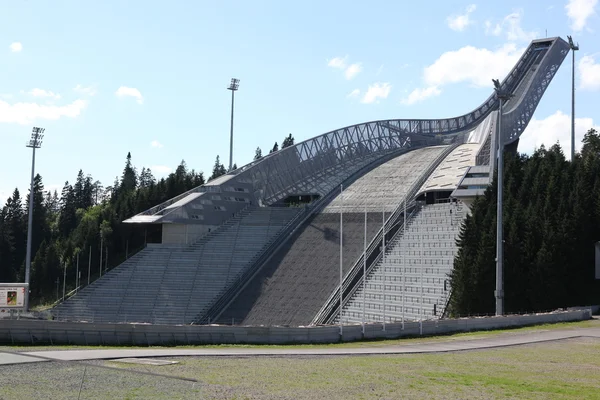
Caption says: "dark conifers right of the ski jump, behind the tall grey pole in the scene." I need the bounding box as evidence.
[450,129,600,315]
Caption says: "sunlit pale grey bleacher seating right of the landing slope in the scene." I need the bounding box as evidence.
[338,202,465,323]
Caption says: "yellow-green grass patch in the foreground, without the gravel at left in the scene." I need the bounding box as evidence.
[99,339,600,399]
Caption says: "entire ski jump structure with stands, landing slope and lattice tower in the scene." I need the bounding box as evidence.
[53,38,569,326]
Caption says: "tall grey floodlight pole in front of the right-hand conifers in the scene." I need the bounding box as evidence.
[492,79,513,315]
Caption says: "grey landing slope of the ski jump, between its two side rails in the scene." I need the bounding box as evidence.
[217,146,446,326]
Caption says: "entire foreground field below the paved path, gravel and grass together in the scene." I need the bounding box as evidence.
[0,339,600,399]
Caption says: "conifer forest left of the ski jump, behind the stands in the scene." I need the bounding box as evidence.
[0,134,294,305]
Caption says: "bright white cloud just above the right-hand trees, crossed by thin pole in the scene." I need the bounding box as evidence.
[519,111,600,158]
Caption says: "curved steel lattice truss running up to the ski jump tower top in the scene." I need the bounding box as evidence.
[127,38,569,223]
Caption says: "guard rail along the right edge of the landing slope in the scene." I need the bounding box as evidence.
[311,143,461,325]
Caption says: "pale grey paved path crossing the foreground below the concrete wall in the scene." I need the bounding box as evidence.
[0,327,600,365]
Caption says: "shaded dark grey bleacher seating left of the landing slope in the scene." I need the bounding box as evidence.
[53,207,303,324]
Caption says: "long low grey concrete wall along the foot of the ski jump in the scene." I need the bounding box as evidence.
[0,309,591,346]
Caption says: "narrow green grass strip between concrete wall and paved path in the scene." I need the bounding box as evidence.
[0,319,600,352]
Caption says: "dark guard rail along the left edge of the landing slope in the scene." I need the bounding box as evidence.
[196,147,420,324]
